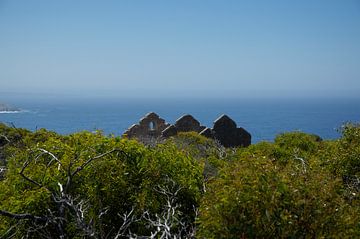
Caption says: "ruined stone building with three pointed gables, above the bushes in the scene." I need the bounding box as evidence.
[124,112,251,147]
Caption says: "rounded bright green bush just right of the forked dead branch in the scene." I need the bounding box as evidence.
[81,140,202,233]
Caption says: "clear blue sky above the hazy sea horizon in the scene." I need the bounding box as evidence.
[0,0,360,98]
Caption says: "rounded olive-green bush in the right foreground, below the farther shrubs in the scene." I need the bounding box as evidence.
[198,157,359,238]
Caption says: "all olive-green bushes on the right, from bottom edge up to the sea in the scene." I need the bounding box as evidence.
[197,126,360,238]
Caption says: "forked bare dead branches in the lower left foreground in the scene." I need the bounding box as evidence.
[0,148,132,238]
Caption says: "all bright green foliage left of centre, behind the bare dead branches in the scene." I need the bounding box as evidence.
[0,127,202,237]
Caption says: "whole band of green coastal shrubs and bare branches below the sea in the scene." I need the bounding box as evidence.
[0,123,360,238]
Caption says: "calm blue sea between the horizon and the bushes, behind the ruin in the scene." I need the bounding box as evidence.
[0,99,360,143]
